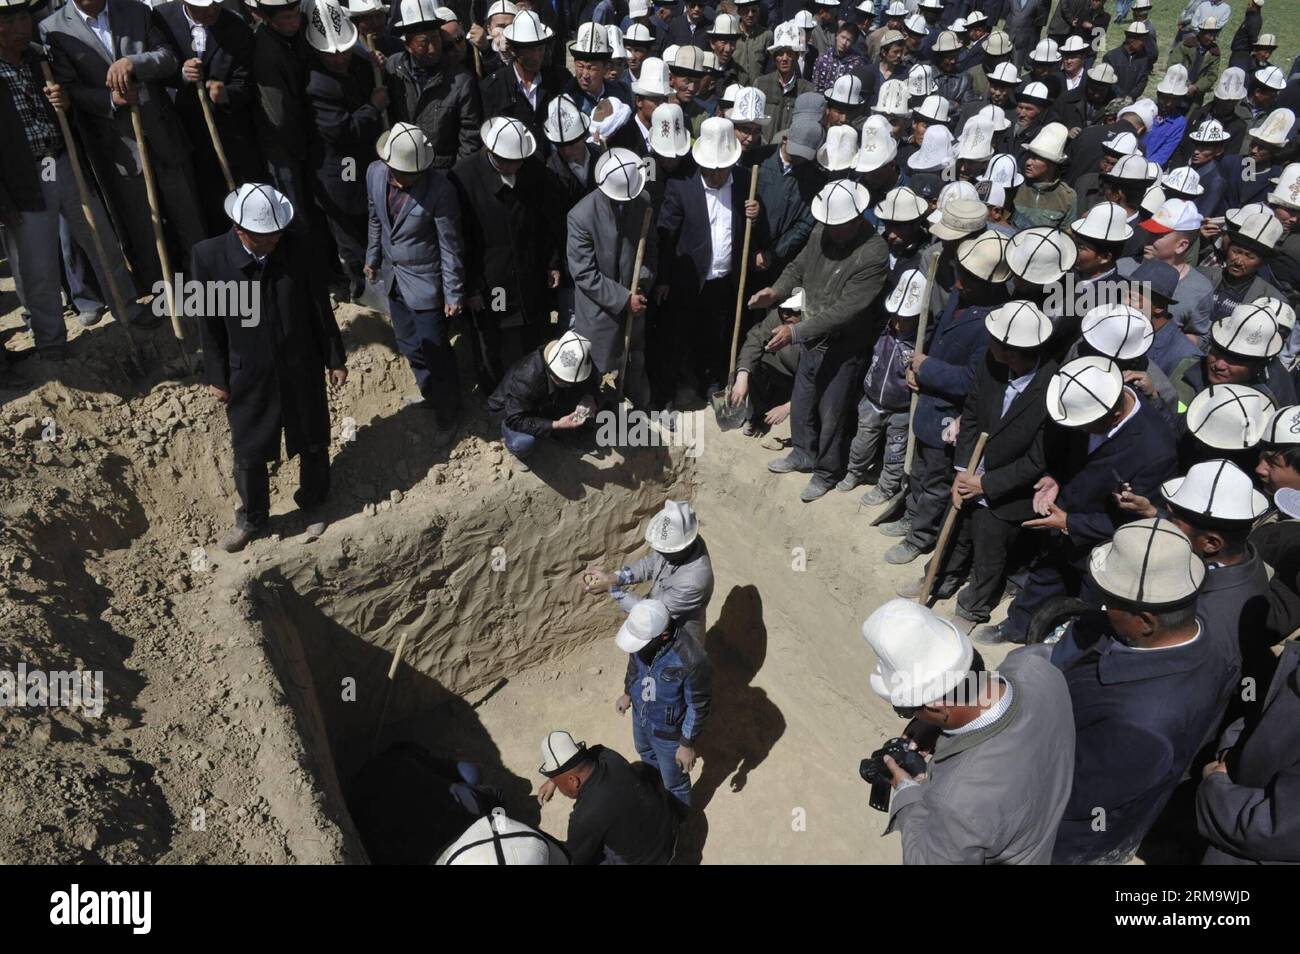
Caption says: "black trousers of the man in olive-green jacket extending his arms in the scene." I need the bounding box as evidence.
[787,341,862,481]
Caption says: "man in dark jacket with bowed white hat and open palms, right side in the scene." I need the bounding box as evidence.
[972,356,1178,655]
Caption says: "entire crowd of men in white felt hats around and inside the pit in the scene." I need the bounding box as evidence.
[0,0,1300,863]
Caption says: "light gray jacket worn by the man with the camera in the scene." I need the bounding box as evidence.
[885,647,1074,864]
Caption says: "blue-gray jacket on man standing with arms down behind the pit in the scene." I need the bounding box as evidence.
[365,160,465,311]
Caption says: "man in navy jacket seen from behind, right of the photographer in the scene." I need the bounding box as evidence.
[1052,519,1240,864]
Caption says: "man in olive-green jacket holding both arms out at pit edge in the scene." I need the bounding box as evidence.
[749,179,889,503]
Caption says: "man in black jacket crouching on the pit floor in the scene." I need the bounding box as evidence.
[537,729,680,864]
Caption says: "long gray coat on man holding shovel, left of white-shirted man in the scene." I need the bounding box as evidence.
[564,190,659,374]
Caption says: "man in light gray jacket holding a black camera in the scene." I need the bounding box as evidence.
[861,599,1075,864]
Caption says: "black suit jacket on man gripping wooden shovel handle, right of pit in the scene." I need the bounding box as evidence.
[954,354,1057,522]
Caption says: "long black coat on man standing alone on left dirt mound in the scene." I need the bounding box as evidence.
[190,235,345,463]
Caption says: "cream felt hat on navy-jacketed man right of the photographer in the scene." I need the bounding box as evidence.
[1088,517,1205,610]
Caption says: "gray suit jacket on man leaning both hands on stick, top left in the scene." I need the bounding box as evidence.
[40,0,190,175]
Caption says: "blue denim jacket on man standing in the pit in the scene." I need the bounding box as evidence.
[623,623,714,745]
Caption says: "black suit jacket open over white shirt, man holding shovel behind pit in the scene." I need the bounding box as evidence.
[658,165,768,295]
